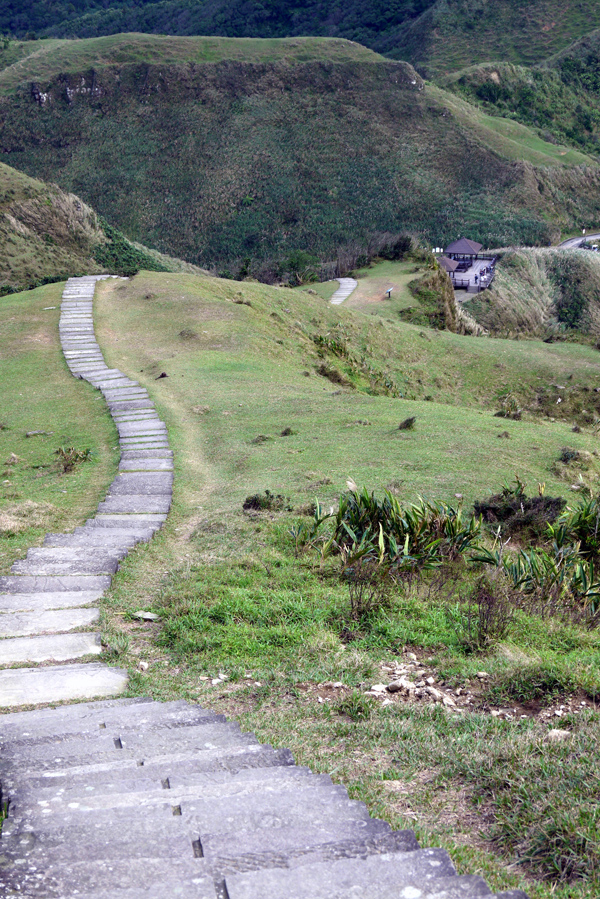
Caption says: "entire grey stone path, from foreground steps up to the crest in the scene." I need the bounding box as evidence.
[0,278,526,899]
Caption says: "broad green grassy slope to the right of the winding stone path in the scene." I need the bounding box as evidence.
[84,273,600,899]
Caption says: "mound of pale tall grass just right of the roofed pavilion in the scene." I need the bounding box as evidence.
[464,249,600,340]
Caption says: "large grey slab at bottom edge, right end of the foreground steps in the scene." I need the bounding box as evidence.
[225,849,492,899]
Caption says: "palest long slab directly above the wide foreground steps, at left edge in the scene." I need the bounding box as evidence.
[0,662,127,708]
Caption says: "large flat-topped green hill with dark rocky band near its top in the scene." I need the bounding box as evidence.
[0,35,600,273]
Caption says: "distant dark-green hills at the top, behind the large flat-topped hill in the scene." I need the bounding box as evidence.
[0,0,600,76]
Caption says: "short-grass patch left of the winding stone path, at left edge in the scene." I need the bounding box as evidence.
[0,284,117,573]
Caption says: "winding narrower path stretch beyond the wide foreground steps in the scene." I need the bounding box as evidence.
[0,276,173,707]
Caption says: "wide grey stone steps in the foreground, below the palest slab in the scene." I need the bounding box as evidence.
[0,700,525,899]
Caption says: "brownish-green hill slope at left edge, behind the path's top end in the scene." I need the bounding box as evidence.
[0,163,202,296]
